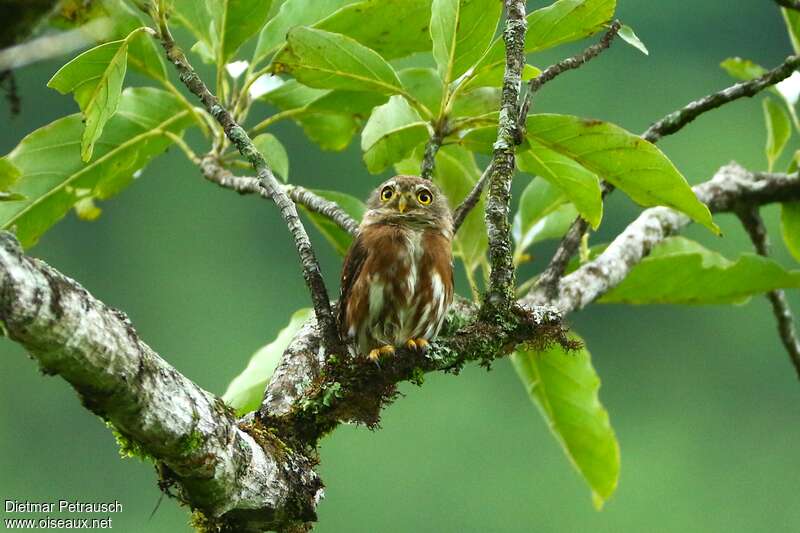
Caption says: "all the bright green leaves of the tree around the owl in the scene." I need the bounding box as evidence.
[0,0,800,516]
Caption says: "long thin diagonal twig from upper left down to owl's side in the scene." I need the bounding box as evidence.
[158,8,343,354]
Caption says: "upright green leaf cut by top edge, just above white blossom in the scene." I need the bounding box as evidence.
[206,0,272,63]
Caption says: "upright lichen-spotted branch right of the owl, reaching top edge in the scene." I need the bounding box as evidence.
[482,0,528,317]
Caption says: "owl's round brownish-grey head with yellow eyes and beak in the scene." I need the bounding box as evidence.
[364,176,453,234]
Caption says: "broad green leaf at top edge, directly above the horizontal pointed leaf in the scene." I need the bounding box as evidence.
[314,0,431,59]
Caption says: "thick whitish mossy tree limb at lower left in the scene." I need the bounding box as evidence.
[0,232,322,531]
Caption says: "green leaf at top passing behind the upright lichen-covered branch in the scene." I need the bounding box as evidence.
[470,0,616,86]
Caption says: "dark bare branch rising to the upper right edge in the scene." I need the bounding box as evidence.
[642,56,800,143]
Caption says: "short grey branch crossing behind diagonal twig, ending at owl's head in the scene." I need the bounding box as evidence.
[199,155,358,236]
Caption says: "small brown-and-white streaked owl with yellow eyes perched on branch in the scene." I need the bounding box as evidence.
[338,176,453,361]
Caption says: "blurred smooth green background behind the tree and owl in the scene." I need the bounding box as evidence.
[0,0,800,533]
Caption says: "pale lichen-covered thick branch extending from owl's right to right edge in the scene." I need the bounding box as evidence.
[521,163,800,315]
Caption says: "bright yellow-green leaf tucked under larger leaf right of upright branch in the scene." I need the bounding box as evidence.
[517,138,603,229]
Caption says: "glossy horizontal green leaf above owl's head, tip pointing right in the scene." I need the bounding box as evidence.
[272,27,403,94]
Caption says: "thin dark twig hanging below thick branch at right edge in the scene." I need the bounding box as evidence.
[736,206,800,378]
